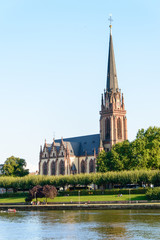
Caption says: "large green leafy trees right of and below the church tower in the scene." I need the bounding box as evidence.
[97,127,160,172]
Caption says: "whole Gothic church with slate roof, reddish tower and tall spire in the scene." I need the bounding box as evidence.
[39,24,127,175]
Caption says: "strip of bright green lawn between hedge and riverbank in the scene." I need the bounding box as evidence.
[0,194,147,203]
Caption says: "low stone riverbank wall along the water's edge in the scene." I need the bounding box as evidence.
[0,202,160,211]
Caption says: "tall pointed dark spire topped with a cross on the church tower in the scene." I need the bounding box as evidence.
[106,21,118,92]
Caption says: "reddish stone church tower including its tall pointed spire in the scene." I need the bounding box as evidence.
[99,24,127,151]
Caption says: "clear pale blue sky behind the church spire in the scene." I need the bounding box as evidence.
[0,0,160,171]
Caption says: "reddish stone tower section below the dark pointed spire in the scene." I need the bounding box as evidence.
[100,90,127,151]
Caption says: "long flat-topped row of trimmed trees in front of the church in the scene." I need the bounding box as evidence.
[0,170,160,191]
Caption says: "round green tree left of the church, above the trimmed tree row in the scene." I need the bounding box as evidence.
[2,156,29,177]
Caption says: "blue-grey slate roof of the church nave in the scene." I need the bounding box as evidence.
[47,134,100,156]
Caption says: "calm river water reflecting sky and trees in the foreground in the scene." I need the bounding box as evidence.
[0,210,160,240]
